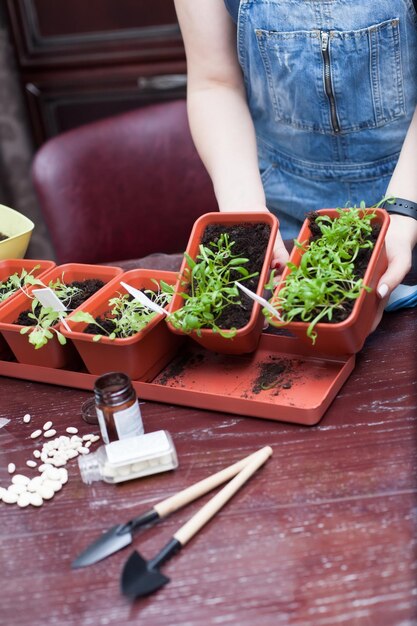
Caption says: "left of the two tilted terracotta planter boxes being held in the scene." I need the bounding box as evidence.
[167,212,278,354]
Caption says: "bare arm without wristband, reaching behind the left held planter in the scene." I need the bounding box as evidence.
[175,0,288,265]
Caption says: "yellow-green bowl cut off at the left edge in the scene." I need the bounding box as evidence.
[0,204,35,259]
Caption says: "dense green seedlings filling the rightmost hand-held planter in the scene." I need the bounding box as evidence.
[263,199,386,344]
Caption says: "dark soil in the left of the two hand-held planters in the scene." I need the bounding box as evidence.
[201,222,271,329]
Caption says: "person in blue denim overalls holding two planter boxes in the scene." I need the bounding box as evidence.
[176,0,417,306]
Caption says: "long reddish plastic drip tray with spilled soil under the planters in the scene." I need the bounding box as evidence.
[0,333,355,425]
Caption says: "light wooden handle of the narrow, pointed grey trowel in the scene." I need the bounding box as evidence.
[153,450,270,518]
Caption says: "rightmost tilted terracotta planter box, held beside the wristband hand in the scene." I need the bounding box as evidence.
[270,209,389,356]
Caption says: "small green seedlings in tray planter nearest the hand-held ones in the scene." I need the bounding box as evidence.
[71,280,173,341]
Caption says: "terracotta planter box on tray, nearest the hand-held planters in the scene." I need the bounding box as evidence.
[61,269,181,381]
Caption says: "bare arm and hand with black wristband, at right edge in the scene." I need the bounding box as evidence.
[378,108,417,298]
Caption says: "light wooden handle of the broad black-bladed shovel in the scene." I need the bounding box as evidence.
[174,446,272,546]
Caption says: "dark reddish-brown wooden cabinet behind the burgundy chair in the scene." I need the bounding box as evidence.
[7,0,186,145]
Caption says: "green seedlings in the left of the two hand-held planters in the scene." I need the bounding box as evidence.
[169,233,258,339]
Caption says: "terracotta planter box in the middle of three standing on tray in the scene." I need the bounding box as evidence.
[0,263,122,368]
